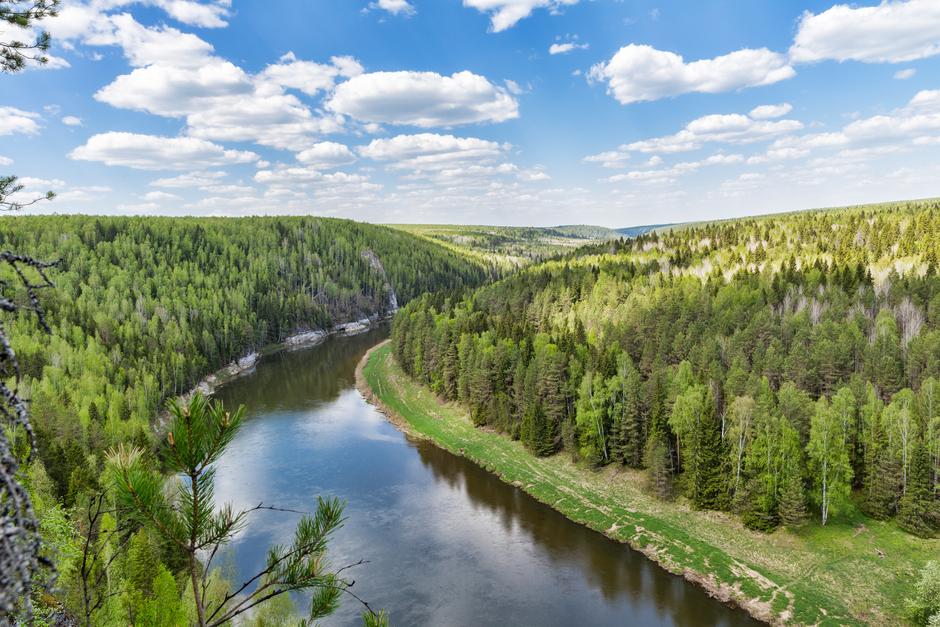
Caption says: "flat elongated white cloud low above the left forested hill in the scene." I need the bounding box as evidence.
[69,132,258,170]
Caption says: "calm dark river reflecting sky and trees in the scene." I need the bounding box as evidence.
[216,329,756,627]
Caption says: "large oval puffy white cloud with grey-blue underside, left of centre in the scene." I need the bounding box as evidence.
[326,71,519,128]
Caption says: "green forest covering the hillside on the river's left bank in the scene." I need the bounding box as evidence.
[0,216,485,625]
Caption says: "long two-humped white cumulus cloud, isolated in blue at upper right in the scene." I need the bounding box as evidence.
[589,44,796,104]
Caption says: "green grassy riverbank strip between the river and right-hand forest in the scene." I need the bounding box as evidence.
[357,343,940,625]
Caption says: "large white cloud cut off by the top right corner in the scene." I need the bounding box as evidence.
[790,0,940,63]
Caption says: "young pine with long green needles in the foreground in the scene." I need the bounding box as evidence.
[108,394,379,627]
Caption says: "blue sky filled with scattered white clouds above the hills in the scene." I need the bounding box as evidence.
[0,0,940,226]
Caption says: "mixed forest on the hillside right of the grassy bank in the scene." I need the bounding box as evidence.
[393,202,940,536]
